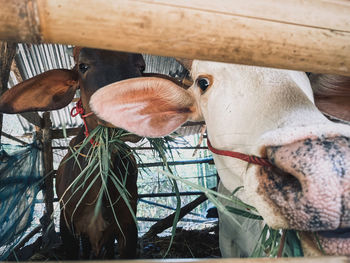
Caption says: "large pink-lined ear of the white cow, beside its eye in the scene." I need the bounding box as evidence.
[90,77,197,137]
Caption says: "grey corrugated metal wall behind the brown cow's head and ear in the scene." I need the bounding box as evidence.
[9,44,184,133]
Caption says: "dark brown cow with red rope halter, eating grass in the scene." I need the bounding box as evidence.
[0,48,145,259]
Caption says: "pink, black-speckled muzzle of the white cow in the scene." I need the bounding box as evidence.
[258,136,350,256]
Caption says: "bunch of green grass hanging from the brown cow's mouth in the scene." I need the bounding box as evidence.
[61,126,137,237]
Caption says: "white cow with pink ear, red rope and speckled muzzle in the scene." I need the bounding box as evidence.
[91,61,350,255]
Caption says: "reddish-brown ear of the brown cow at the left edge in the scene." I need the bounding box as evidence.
[0,69,78,113]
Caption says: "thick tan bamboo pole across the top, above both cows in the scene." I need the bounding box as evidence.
[0,0,350,76]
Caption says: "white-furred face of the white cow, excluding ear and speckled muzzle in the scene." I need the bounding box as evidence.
[191,61,350,256]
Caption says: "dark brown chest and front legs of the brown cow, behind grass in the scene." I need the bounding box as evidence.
[56,130,137,259]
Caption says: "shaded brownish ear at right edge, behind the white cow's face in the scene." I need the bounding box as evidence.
[310,74,350,122]
